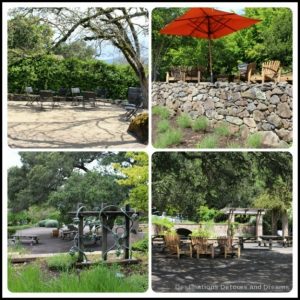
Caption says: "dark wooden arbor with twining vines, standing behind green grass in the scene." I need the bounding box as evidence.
[69,205,138,263]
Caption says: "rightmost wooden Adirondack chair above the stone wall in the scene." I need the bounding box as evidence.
[248,60,281,83]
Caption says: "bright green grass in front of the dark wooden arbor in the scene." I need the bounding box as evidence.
[8,264,148,293]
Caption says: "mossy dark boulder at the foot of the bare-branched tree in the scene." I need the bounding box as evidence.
[127,113,148,144]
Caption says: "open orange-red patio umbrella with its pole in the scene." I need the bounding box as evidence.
[160,7,260,81]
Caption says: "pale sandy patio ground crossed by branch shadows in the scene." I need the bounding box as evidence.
[7,101,146,149]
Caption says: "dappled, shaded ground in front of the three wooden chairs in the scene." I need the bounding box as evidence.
[152,245,292,293]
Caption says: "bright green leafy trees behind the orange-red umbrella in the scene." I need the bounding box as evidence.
[152,8,293,80]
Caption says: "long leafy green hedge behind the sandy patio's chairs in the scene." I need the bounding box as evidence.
[8,55,139,99]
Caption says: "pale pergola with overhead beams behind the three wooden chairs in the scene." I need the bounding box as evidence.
[221,207,266,237]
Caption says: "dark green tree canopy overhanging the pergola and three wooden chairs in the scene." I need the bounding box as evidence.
[152,152,292,221]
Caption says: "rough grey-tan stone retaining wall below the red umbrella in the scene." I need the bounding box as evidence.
[152,81,293,147]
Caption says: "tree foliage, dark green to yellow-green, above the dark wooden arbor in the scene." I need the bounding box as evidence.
[8,152,148,223]
